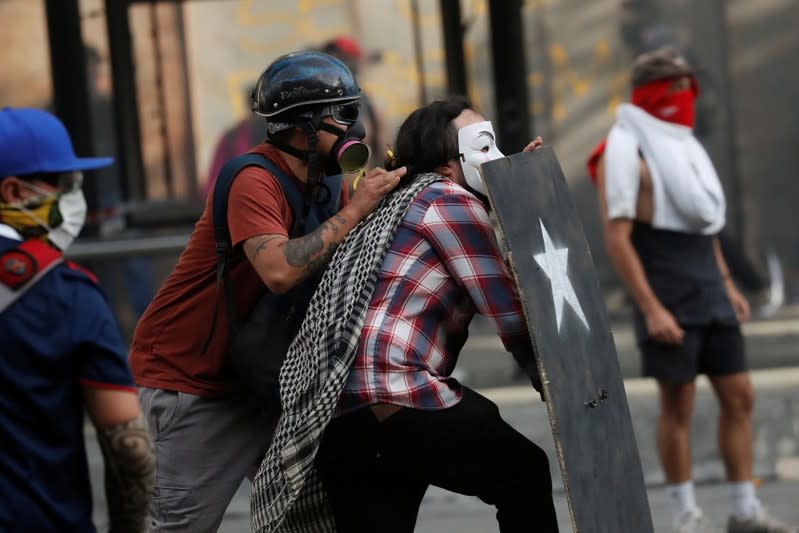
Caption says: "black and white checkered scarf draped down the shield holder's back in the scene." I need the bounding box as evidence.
[250,173,446,533]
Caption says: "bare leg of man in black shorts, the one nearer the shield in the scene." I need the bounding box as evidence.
[657,383,696,484]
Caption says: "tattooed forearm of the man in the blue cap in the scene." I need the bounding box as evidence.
[97,415,155,533]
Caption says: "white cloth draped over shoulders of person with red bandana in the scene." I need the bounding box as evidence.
[605,104,726,235]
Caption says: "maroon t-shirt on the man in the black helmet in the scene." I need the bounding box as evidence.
[130,144,348,396]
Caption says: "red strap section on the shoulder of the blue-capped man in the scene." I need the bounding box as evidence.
[0,239,63,313]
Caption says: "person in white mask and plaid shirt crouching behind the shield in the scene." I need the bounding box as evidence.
[288,98,558,533]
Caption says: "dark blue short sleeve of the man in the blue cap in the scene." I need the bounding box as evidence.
[70,284,136,391]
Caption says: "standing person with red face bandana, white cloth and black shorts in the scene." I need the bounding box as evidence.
[588,47,797,533]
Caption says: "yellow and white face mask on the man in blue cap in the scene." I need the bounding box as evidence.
[0,172,87,252]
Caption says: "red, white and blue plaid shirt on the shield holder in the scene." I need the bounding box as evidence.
[339,181,533,414]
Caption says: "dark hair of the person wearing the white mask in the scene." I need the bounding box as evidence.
[386,95,477,179]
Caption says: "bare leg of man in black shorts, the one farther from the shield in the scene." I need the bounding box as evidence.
[710,372,754,481]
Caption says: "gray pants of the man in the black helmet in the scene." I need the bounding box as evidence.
[139,387,275,533]
